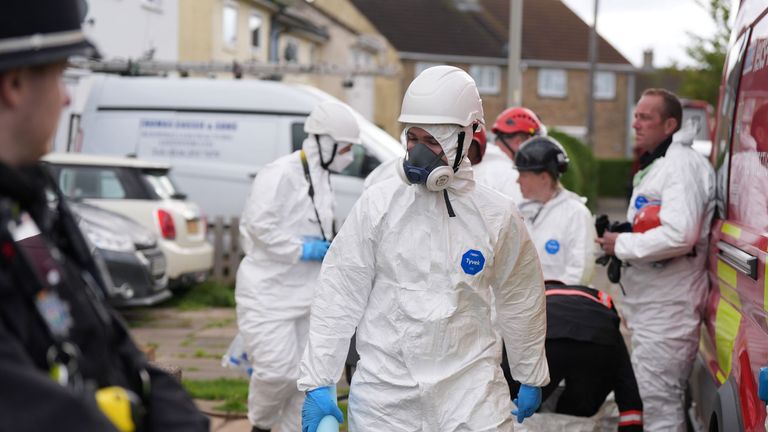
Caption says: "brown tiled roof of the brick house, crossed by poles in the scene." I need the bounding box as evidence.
[351,0,630,65]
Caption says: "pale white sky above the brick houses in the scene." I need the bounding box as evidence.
[560,0,738,67]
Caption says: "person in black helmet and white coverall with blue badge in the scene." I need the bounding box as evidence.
[515,137,597,285]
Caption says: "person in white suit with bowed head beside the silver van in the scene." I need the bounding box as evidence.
[235,101,360,432]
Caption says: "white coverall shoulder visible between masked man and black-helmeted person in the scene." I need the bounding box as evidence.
[472,143,523,202]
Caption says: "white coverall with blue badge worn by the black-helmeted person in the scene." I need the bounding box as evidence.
[519,187,597,285]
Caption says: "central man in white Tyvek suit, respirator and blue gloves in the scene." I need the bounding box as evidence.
[298,66,549,432]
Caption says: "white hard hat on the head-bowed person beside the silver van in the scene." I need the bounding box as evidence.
[304,101,360,144]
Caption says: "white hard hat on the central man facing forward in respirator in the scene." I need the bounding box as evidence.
[397,66,484,127]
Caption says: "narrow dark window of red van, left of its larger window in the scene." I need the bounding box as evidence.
[712,32,749,219]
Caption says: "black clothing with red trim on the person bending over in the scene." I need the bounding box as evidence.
[502,284,643,432]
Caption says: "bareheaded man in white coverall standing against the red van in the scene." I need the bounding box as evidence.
[598,89,715,432]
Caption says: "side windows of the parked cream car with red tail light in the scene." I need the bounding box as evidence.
[49,164,152,200]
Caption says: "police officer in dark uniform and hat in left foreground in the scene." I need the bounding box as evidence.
[0,0,208,432]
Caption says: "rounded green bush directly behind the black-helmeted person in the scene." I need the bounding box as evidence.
[549,130,598,211]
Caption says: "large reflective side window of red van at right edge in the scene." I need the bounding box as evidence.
[728,24,768,231]
